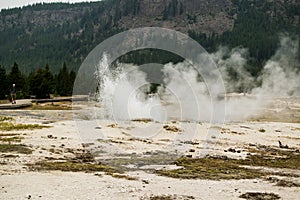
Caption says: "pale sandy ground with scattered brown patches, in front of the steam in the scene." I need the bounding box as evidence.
[0,101,300,199]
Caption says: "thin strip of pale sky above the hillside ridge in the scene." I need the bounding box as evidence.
[0,0,99,10]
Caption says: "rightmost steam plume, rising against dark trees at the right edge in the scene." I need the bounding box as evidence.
[252,37,300,98]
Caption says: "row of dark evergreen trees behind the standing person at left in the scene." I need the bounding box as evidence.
[0,63,76,99]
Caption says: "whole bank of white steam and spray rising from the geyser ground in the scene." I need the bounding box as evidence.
[97,37,300,122]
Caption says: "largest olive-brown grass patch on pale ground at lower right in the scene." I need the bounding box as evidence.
[157,147,300,180]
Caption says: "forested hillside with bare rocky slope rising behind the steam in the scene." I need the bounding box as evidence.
[0,0,300,98]
